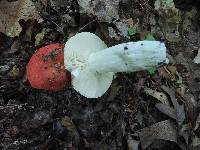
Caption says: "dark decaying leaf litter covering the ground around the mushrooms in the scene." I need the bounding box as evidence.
[0,0,200,150]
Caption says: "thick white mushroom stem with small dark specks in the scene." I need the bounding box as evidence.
[88,41,168,73]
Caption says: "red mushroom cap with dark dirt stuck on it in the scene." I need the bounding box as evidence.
[27,43,68,91]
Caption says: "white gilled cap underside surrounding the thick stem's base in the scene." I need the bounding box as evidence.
[64,32,114,98]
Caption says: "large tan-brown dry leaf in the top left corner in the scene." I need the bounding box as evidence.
[0,0,41,37]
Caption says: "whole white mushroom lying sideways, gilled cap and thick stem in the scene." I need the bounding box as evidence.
[64,32,168,98]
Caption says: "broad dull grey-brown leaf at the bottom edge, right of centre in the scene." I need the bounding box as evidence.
[139,120,177,149]
